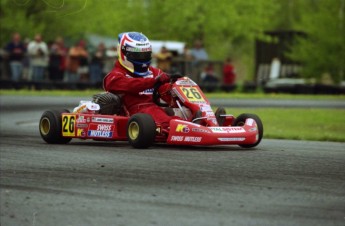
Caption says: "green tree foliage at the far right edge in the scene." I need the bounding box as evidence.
[289,0,345,82]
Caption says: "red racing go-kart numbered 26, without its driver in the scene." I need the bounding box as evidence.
[39,76,263,148]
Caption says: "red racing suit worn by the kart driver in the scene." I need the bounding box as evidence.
[103,62,176,128]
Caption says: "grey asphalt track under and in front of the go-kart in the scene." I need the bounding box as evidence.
[0,96,345,226]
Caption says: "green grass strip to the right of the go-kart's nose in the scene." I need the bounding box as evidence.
[226,108,345,142]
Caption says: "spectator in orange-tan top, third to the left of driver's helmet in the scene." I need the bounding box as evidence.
[64,40,88,82]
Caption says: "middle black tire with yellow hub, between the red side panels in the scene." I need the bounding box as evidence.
[127,113,156,149]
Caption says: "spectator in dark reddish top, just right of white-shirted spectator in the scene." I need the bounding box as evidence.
[49,37,68,81]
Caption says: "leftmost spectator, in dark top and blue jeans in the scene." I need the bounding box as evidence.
[5,33,26,81]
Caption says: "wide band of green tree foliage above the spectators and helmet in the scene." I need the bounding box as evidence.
[0,0,279,81]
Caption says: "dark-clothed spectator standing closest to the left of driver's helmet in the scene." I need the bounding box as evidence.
[90,43,106,83]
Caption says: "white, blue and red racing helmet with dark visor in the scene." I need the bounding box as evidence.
[117,32,152,76]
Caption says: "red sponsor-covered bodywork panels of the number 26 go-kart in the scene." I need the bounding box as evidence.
[62,77,259,145]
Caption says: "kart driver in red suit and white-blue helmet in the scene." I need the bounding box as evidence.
[103,32,178,131]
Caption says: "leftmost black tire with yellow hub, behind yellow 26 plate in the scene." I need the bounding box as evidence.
[39,109,72,144]
